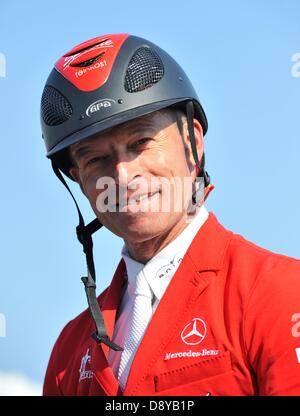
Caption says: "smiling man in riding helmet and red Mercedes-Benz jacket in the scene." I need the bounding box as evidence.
[41,35,300,395]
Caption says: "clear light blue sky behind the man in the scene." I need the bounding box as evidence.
[0,0,300,387]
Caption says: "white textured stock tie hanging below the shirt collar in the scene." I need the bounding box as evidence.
[118,272,152,390]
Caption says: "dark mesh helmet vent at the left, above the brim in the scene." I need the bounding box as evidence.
[41,85,73,126]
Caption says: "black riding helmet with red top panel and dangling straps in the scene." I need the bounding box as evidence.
[41,34,210,351]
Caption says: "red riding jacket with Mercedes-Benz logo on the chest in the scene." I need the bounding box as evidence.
[44,213,300,396]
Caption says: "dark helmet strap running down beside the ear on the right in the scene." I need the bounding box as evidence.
[186,101,214,203]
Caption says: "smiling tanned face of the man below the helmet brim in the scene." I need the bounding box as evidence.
[70,110,203,243]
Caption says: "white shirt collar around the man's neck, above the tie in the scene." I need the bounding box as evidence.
[122,205,209,300]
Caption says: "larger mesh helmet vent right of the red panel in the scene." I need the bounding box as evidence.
[124,47,164,92]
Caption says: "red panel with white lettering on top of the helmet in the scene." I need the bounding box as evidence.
[55,34,129,91]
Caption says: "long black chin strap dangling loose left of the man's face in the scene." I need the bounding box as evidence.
[51,160,123,351]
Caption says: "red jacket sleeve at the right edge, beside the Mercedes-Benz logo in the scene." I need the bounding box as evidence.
[244,256,300,396]
